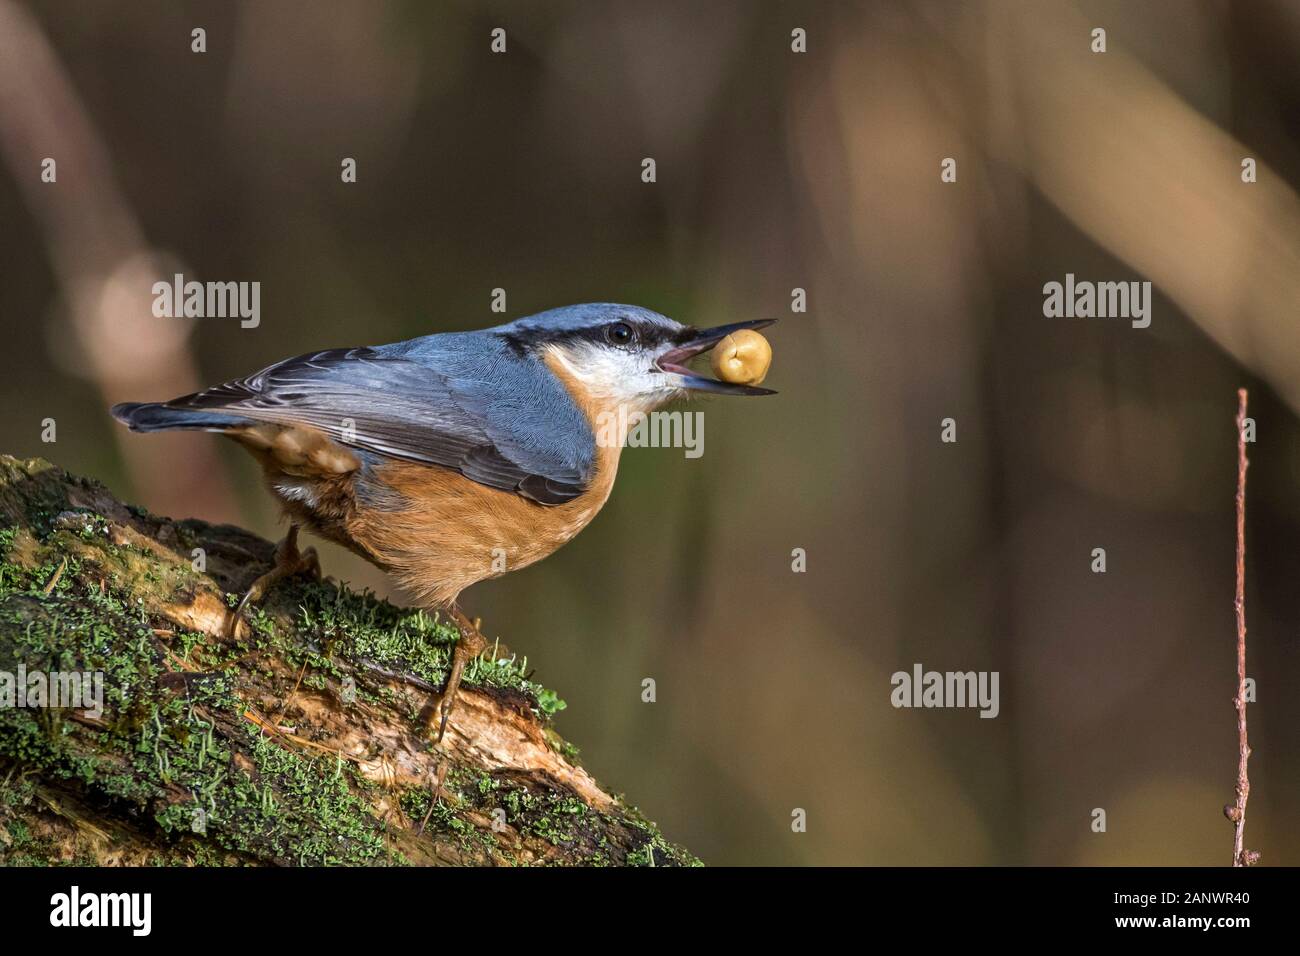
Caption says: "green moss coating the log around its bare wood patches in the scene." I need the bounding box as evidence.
[0,457,698,865]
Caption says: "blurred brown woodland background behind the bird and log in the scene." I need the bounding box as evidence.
[0,0,1300,865]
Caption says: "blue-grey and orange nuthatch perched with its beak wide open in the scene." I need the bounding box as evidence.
[111,303,776,743]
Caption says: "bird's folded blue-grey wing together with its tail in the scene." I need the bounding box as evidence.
[114,336,594,505]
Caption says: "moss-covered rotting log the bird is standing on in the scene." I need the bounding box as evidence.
[0,457,697,866]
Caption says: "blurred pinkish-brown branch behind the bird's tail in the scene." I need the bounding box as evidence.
[0,0,238,519]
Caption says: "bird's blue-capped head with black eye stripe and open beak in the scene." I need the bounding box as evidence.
[498,302,776,411]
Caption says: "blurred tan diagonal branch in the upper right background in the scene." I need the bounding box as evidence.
[993,4,1300,411]
